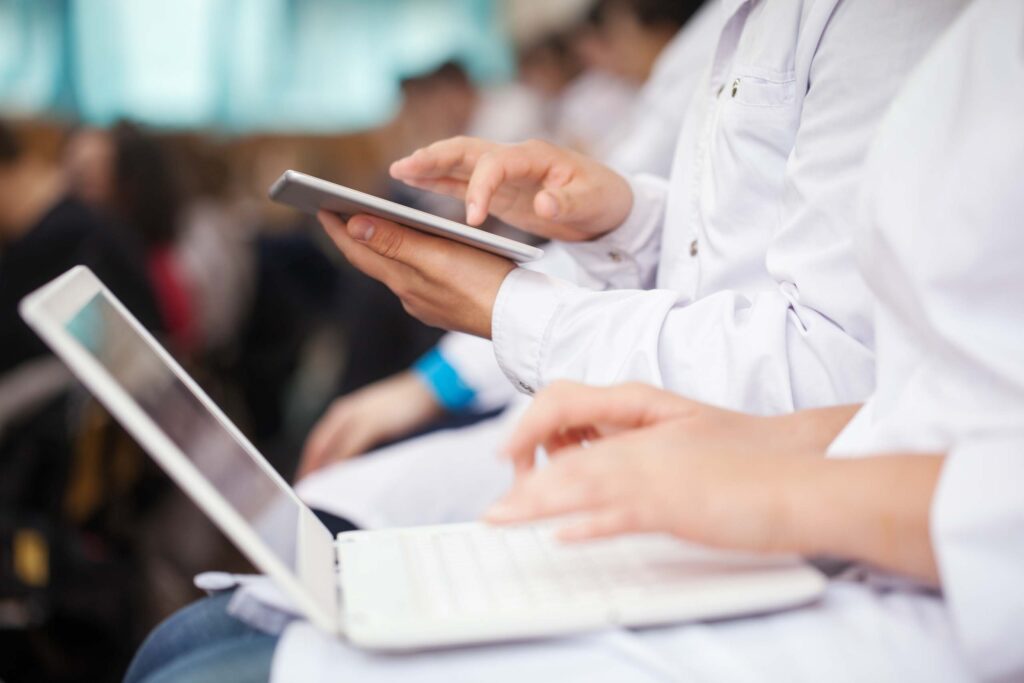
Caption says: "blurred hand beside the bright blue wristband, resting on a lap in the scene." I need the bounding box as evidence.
[295,371,442,480]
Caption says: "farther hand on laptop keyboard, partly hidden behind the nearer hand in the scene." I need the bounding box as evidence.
[503,382,675,469]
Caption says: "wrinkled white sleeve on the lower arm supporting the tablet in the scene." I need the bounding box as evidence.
[493,270,871,414]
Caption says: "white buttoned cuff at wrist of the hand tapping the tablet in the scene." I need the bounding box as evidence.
[565,175,667,289]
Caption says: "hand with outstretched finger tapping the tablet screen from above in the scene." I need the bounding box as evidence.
[391,137,633,242]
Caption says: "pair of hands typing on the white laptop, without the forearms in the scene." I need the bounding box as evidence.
[485,383,852,552]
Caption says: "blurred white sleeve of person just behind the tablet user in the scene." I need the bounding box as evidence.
[602,0,722,175]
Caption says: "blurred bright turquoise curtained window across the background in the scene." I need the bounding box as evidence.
[0,0,512,131]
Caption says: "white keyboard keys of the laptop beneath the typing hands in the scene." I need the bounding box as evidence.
[402,527,679,616]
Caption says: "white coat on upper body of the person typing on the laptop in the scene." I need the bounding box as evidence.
[833,0,1024,681]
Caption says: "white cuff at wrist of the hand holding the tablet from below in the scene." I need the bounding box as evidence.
[490,268,571,395]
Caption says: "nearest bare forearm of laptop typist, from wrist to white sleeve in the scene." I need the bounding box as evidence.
[774,454,944,585]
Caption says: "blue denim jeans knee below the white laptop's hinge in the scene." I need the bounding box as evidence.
[124,593,278,683]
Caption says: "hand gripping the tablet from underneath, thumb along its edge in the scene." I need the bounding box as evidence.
[317,211,515,339]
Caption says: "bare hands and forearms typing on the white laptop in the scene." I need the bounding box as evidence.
[487,383,944,584]
